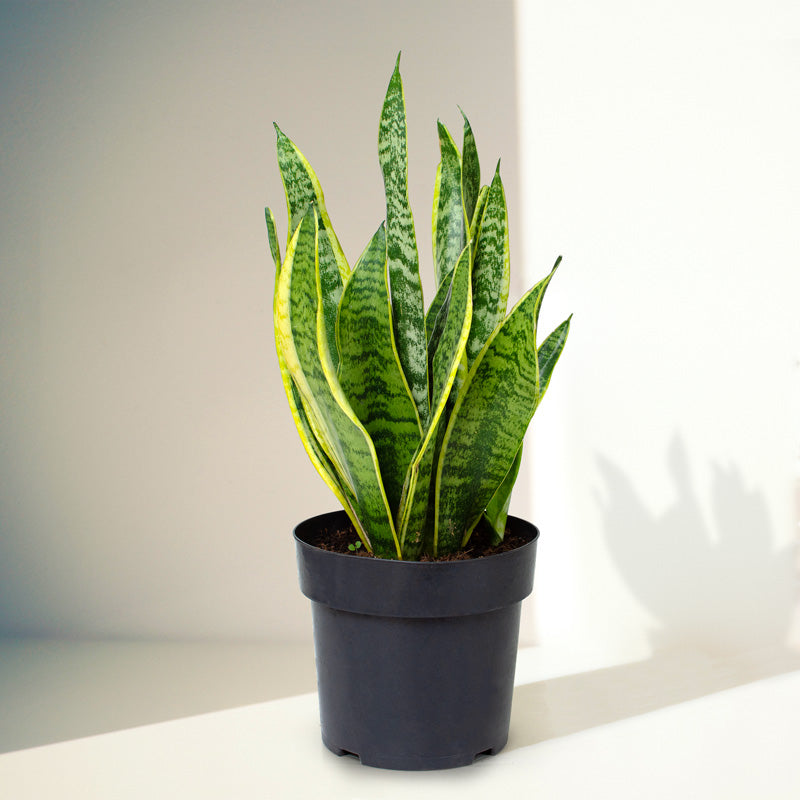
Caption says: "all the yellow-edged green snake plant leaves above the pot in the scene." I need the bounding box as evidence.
[266,56,570,560]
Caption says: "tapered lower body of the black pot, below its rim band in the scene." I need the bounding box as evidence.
[312,603,521,770]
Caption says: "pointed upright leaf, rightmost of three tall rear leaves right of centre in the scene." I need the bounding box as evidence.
[467,164,511,363]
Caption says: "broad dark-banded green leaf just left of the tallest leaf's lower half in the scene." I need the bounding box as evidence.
[338,225,427,518]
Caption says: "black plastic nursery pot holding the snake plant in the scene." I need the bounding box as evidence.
[294,511,539,770]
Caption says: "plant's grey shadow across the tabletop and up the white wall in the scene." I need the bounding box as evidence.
[509,438,800,748]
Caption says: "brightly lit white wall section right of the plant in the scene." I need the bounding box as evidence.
[517,0,800,660]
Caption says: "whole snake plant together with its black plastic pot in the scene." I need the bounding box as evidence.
[266,56,570,769]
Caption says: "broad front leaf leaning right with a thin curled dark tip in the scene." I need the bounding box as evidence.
[435,272,553,553]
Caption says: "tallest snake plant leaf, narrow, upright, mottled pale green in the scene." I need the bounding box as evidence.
[378,56,430,423]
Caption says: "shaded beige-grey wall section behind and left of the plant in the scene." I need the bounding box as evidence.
[0,0,525,638]
